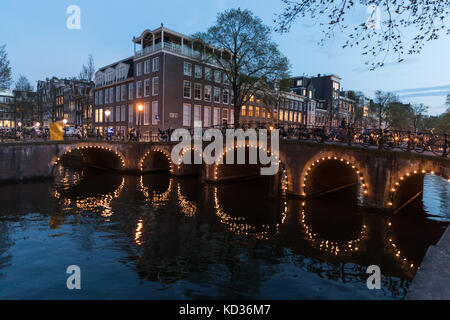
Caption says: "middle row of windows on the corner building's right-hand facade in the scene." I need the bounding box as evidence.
[183,81,234,104]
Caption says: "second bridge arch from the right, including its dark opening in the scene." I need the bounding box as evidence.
[300,152,369,201]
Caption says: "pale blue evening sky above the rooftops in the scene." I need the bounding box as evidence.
[0,0,450,114]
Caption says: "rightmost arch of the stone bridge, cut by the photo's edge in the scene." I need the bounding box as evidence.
[386,167,450,213]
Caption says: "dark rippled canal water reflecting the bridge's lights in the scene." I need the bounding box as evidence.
[0,167,450,299]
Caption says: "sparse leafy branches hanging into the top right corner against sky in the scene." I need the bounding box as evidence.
[275,0,450,70]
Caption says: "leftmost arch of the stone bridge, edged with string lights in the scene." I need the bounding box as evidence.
[51,143,126,171]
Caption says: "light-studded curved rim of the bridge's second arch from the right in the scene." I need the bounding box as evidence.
[300,153,369,202]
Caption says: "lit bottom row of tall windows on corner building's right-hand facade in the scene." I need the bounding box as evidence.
[183,103,234,127]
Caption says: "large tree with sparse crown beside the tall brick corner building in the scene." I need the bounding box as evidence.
[193,9,289,127]
